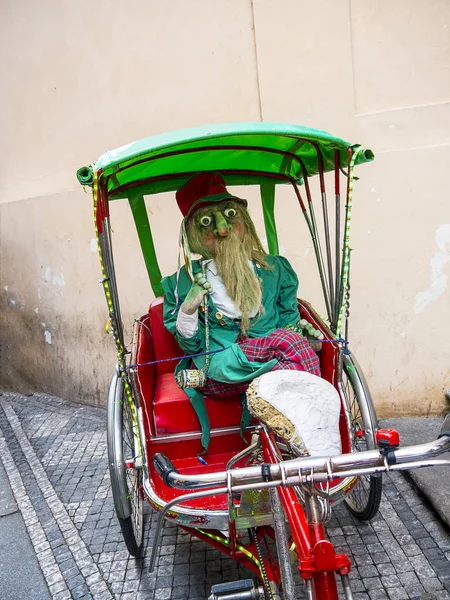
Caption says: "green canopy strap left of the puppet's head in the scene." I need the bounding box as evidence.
[128,193,163,298]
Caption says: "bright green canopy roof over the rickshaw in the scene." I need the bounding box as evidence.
[79,123,374,199]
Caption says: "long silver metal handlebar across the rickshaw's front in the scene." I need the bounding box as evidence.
[153,422,450,490]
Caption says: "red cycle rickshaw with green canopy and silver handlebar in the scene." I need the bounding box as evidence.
[77,123,450,600]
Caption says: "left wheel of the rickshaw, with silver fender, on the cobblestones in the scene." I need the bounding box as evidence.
[107,373,144,556]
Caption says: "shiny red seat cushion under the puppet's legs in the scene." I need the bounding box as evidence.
[153,373,242,435]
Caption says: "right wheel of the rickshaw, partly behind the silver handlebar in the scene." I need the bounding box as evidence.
[342,355,383,521]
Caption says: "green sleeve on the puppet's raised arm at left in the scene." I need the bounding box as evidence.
[161,271,205,354]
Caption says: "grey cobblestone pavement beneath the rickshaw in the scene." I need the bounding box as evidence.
[0,393,450,600]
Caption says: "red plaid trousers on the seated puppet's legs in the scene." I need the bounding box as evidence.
[198,329,320,397]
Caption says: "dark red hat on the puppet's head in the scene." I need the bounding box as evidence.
[175,171,247,217]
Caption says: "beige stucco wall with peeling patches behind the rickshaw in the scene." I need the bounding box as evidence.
[0,0,450,415]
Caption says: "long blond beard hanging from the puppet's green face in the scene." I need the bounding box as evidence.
[212,231,262,335]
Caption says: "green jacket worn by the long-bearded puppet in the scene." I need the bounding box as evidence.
[162,255,299,449]
